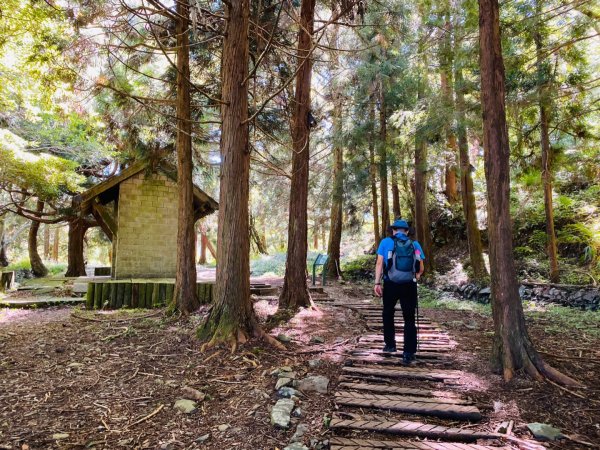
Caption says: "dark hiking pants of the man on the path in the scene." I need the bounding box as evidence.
[383,280,417,353]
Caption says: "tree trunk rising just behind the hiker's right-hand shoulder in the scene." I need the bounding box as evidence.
[415,58,435,272]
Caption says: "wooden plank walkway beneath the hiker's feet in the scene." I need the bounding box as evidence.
[330,302,508,450]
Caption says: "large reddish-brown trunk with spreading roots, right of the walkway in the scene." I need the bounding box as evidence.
[479,0,577,385]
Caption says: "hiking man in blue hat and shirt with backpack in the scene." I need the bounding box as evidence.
[375,219,425,364]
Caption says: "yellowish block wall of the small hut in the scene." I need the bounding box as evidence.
[113,172,178,279]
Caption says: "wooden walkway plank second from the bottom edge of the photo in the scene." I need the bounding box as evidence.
[329,413,499,442]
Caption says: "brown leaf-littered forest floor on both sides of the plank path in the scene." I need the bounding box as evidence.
[0,285,600,450]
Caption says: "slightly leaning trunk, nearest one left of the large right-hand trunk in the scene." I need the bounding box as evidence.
[454,67,487,280]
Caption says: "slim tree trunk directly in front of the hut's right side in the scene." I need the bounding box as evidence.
[173,0,200,314]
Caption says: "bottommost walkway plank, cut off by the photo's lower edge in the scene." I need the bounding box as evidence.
[329,436,510,450]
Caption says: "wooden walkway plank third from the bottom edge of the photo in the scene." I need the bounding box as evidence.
[335,392,481,422]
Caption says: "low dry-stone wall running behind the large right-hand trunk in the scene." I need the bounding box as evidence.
[444,282,600,311]
